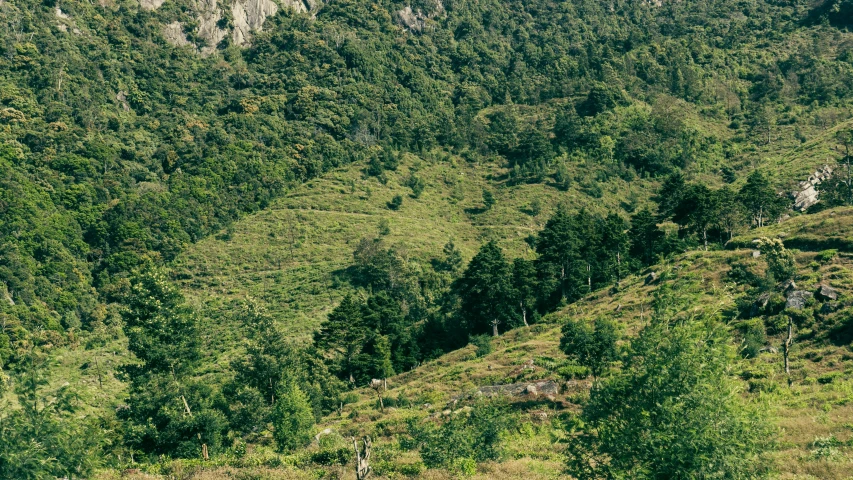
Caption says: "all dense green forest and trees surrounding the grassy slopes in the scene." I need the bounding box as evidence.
[0,0,853,478]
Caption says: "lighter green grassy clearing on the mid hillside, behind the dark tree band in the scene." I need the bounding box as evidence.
[175,152,651,338]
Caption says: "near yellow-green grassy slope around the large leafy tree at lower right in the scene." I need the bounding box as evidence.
[133,212,853,479]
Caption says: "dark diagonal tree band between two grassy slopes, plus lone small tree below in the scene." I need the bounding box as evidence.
[314,167,788,385]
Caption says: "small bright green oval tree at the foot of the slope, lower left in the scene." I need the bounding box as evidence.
[272,381,314,452]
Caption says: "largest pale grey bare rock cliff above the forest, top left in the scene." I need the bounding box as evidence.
[151,0,319,55]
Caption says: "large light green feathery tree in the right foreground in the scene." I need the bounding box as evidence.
[569,286,772,478]
